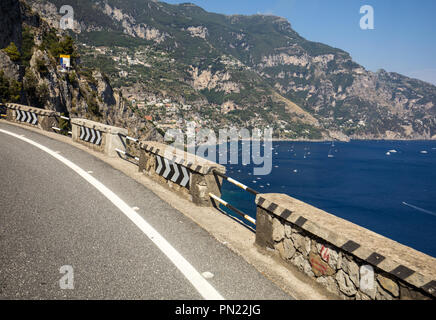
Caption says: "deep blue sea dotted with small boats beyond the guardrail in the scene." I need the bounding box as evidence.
[218,141,436,257]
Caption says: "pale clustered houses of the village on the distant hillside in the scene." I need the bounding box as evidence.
[78,43,278,133]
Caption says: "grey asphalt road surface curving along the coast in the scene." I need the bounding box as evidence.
[0,122,292,299]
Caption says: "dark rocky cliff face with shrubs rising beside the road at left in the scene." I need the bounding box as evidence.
[0,1,162,140]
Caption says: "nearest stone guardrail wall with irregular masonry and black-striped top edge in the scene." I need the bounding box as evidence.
[256,194,436,300]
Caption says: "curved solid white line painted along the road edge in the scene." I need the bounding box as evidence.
[0,129,224,300]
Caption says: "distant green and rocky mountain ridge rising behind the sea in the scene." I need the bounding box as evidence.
[3,0,436,140]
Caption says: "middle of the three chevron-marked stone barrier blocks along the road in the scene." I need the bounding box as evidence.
[71,118,127,157]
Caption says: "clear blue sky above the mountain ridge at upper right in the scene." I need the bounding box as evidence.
[164,0,436,84]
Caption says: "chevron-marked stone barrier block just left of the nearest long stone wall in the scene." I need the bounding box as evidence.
[139,141,226,207]
